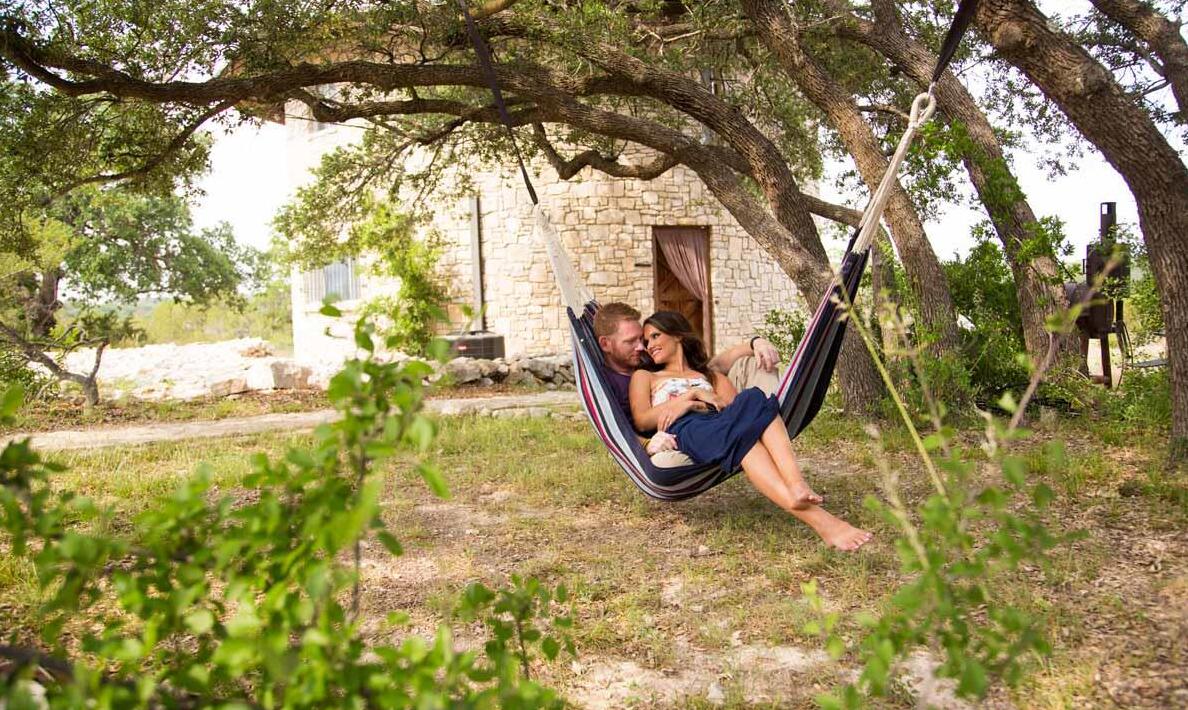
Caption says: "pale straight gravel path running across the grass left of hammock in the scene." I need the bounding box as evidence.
[0,391,579,451]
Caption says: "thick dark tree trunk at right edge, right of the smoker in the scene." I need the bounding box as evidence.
[974,0,1188,461]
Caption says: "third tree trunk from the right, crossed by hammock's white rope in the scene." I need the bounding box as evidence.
[743,0,958,353]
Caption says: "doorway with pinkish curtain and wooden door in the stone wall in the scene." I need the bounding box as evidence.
[652,227,714,354]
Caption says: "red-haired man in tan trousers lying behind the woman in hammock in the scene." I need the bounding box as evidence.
[594,303,779,467]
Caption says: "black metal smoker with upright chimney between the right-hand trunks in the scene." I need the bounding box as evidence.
[1070,202,1130,388]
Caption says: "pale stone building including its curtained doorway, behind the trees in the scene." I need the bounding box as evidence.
[286,104,800,360]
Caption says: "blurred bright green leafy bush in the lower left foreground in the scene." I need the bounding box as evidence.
[0,309,571,708]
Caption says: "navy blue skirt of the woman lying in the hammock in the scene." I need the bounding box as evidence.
[668,387,779,473]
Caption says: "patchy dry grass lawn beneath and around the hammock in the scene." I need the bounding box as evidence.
[0,413,1188,708]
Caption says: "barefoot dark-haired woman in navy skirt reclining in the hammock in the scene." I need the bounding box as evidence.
[631,311,871,551]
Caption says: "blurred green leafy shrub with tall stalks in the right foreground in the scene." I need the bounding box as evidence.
[803,298,1079,708]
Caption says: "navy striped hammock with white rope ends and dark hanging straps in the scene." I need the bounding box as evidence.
[459,0,977,501]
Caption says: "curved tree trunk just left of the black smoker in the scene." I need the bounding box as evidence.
[832,0,1079,362]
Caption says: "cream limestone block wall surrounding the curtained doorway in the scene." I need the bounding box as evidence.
[290,111,802,368]
